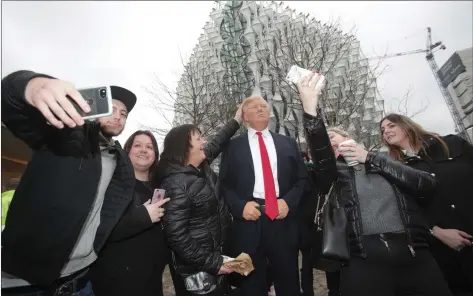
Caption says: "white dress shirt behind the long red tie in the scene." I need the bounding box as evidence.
[248,127,279,199]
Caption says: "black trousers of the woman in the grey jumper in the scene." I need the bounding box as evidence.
[340,234,452,296]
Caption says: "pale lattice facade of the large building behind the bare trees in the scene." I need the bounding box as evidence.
[174,1,384,149]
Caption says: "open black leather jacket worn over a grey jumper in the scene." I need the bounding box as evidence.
[304,114,436,258]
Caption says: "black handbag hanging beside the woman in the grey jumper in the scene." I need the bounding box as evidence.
[313,184,350,271]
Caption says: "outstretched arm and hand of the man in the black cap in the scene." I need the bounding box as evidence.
[1,70,90,150]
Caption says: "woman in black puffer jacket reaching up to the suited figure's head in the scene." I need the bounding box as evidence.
[156,108,243,296]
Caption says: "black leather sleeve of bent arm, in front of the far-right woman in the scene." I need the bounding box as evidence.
[365,152,436,197]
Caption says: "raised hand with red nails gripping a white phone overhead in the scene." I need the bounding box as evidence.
[297,72,325,116]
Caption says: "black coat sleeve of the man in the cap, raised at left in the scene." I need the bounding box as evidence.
[1,71,55,150]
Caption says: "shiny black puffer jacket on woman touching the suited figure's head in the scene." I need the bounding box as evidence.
[158,120,239,276]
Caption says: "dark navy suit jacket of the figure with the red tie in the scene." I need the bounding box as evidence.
[220,133,307,255]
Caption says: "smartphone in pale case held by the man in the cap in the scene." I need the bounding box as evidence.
[69,86,113,120]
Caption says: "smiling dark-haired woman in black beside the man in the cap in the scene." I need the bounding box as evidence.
[90,130,170,296]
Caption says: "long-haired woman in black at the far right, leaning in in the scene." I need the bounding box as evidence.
[380,114,473,295]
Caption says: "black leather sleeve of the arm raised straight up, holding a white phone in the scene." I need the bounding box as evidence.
[303,112,338,195]
